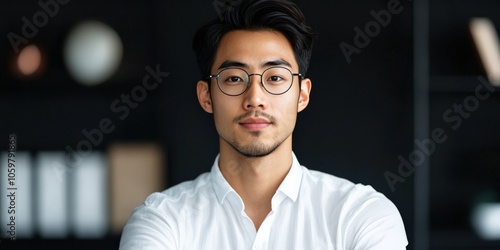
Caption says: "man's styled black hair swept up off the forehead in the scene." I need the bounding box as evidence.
[193,0,315,79]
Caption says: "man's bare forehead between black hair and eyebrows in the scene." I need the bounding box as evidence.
[212,30,298,72]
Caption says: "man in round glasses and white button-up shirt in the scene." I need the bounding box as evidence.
[120,0,407,250]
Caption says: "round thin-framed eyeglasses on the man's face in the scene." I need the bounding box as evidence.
[208,66,303,96]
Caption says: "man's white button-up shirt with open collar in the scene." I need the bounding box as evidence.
[120,155,408,250]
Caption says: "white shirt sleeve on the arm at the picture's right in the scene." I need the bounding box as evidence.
[345,188,408,250]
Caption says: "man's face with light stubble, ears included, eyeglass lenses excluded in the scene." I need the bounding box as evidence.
[198,30,311,157]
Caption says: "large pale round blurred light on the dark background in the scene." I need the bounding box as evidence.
[64,21,123,86]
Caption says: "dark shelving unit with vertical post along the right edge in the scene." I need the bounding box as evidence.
[414,0,500,250]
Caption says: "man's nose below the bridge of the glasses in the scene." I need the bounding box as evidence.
[243,74,267,110]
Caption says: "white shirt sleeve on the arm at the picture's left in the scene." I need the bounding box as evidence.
[120,205,177,250]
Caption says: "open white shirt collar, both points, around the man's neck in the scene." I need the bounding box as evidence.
[210,152,302,203]
